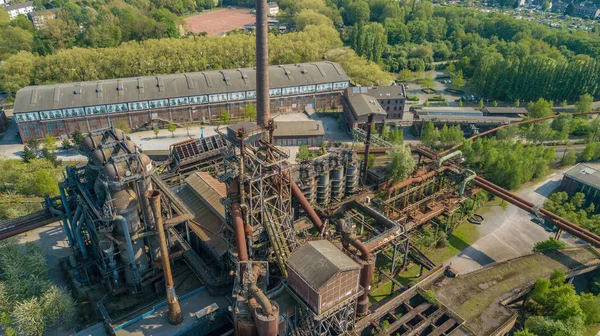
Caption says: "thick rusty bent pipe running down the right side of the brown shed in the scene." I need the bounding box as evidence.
[337,219,375,316]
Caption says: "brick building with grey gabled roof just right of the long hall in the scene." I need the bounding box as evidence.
[344,85,406,128]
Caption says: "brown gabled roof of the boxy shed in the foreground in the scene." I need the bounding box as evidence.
[287,240,360,290]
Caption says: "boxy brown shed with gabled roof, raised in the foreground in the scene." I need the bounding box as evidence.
[287,240,360,315]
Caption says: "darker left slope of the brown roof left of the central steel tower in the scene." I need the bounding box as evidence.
[176,185,227,258]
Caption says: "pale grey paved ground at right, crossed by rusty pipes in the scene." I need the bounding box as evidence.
[449,165,585,273]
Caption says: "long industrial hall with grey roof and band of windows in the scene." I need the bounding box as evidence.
[14,62,350,141]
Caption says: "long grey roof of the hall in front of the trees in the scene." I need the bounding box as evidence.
[14,62,350,113]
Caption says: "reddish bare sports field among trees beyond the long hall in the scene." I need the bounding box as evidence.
[185,8,256,35]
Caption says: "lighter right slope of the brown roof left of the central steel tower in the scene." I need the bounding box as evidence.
[185,172,227,221]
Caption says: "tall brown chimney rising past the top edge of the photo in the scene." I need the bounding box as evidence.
[256,0,271,126]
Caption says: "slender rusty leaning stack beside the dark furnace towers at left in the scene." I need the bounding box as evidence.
[146,190,183,325]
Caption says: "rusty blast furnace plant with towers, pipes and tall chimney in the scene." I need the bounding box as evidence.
[0,0,600,336]
